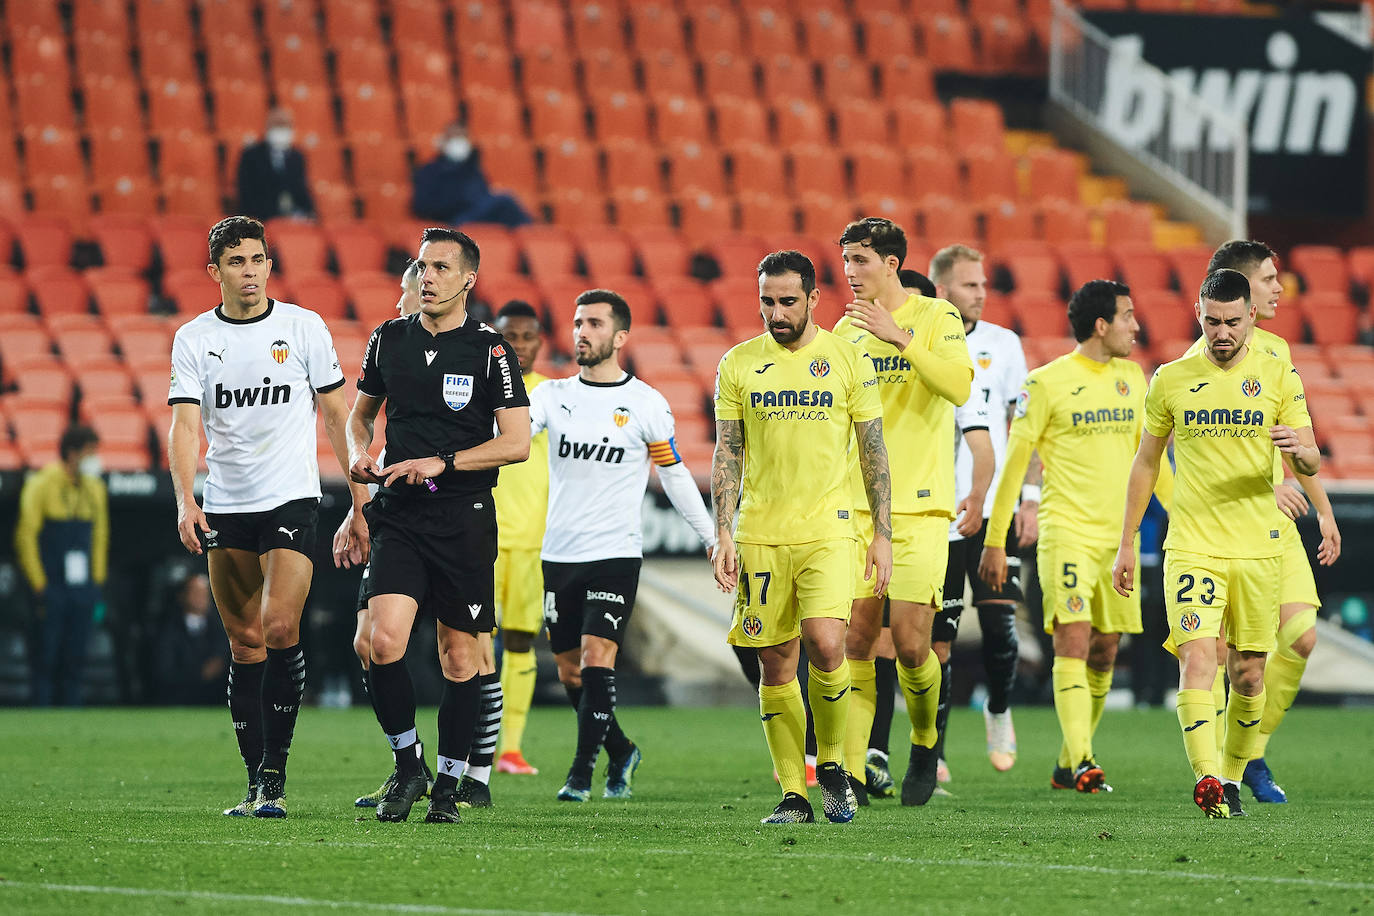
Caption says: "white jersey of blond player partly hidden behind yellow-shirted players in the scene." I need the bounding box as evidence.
[949,321,1026,541]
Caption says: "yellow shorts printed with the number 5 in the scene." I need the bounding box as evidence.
[1036,541,1140,633]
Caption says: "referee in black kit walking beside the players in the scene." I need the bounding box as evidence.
[348,228,529,823]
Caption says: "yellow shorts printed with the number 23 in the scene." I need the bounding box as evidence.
[1164,551,1283,654]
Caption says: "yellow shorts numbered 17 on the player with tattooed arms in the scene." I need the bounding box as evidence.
[727,537,853,648]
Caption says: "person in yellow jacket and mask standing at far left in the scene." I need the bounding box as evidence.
[14,426,110,706]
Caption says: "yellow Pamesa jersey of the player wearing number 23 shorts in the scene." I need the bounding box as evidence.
[1145,349,1312,558]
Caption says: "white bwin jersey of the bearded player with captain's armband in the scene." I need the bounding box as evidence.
[529,375,692,563]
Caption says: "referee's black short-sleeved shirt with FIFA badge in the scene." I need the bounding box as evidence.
[357,314,529,500]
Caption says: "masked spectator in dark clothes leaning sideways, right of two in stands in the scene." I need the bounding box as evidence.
[411,124,530,227]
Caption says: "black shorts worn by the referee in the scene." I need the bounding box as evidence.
[359,493,496,633]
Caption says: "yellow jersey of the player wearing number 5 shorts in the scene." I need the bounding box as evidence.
[993,350,1146,547]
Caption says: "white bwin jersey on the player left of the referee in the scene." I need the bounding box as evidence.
[168,299,344,512]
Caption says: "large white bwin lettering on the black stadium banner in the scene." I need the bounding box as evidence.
[1099,32,1359,155]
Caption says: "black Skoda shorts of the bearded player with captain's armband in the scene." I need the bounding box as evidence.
[544,558,643,655]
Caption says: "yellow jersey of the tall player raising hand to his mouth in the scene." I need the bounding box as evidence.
[835,294,973,519]
